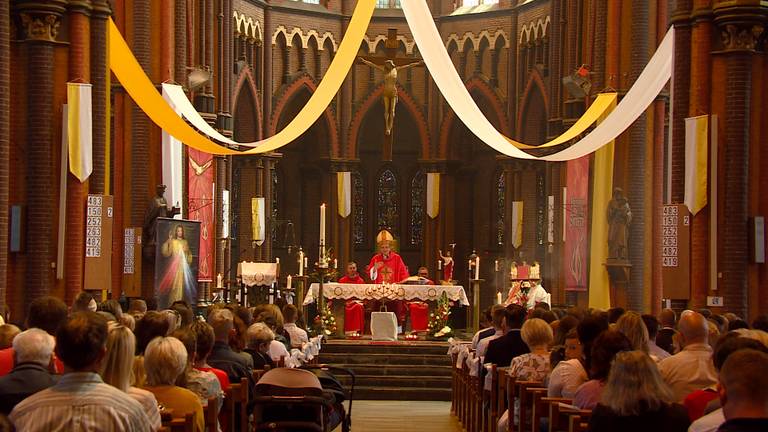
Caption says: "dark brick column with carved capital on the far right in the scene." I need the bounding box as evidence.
[713,0,768,316]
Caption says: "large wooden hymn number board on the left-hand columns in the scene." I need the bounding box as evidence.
[84,195,114,293]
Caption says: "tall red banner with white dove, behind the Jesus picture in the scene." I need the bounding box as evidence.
[187,148,216,282]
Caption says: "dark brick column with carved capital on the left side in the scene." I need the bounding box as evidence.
[14,0,66,303]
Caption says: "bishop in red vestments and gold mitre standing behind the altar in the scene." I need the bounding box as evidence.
[367,230,409,328]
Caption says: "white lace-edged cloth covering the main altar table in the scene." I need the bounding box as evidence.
[304,282,469,306]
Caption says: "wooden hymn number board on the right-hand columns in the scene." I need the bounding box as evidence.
[661,204,691,300]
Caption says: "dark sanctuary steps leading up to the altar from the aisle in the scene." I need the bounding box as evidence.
[320,340,451,401]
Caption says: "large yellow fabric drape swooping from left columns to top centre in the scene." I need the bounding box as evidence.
[107,0,376,155]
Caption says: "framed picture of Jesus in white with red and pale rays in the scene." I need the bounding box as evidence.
[155,218,200,309]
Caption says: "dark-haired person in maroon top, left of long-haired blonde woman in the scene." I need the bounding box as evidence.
[573,330,632,409]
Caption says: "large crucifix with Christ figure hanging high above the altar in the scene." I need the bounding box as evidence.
[358,29,423,161]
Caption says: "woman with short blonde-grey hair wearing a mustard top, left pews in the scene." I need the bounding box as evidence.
[144,337,205,432]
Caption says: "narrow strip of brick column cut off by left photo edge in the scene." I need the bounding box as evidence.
[0,1,11,316]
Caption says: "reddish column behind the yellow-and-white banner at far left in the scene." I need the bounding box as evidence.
[64,0,93,304]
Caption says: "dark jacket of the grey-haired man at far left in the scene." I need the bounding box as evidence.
[0,363,59,415]
